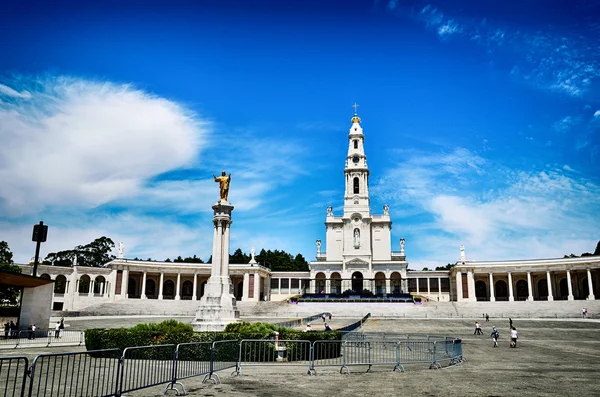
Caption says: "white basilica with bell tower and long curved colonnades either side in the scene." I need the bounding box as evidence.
[22,108,600,311]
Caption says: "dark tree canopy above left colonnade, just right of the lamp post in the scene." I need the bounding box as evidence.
[43,236,115,267]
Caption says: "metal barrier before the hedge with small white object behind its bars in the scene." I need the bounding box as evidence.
[237,339,311,375]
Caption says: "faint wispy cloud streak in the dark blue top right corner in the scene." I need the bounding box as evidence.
[396,4,600,97]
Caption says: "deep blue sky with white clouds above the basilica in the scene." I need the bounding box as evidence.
[0,0,600,269]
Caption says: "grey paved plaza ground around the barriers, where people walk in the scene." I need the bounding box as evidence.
[2,318,600,397]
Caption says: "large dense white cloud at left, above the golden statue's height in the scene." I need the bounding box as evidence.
[0,77,208,216]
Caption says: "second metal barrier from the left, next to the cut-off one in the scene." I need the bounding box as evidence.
[29,349,121,396]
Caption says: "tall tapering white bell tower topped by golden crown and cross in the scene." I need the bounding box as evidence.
[344,104,370,218]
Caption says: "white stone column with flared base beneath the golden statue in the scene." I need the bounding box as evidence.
[192,201,240,332]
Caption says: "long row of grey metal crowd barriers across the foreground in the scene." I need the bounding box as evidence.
[0,332,463,397]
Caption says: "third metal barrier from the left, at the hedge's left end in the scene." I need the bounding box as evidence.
[119,345,179,395]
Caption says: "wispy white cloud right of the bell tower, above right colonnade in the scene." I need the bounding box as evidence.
[373,149,600,264]
